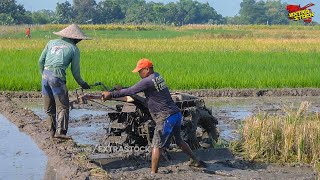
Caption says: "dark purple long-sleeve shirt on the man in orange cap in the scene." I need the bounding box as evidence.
[111,72,180,115]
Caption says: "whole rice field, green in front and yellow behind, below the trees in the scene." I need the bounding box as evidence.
[0,25,320,91]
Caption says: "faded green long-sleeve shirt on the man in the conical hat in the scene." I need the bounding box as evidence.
[39,38,84,85]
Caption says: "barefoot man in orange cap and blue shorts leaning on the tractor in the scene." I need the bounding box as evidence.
[102,59,205,174]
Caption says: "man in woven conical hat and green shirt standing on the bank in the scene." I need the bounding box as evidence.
[39,24,90,138]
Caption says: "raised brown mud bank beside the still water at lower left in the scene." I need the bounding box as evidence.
[0,96,105,179]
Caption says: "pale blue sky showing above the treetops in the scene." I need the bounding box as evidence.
[16,0,320,22]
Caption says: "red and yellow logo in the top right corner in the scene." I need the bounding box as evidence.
[287,3,314,23]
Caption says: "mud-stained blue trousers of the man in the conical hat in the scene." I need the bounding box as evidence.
[42,70,69,136]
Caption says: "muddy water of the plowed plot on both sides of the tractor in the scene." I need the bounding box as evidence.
[18,96,320,144]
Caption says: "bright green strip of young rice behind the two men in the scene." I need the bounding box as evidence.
[0,48,320,91]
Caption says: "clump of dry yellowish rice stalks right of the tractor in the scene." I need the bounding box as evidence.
[241,102,320,172]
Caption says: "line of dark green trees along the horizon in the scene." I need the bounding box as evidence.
[0,0,304,26]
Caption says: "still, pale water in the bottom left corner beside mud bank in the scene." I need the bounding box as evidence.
[0,114,47,179]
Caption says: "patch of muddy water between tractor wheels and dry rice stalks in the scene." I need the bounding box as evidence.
[205,96,320,141]
